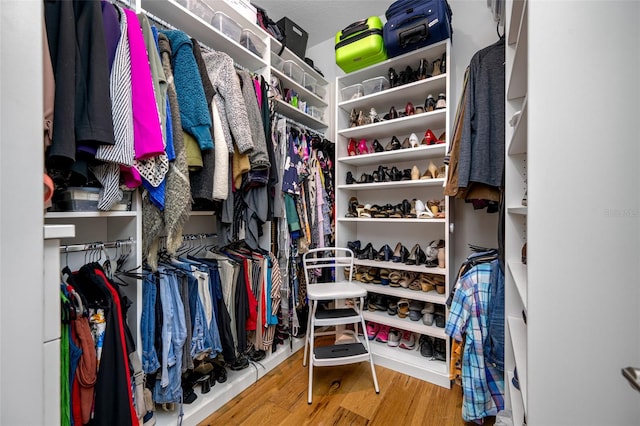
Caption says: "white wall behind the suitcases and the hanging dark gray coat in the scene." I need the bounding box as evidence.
[307,0,504,269]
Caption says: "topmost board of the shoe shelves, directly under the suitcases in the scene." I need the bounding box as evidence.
[337,39,449,90]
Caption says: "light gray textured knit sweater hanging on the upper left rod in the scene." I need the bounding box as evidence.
[202,51,254,153]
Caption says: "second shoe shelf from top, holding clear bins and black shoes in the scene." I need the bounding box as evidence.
[338,73,447,113]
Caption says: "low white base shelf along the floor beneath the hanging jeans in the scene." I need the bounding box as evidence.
[155,339,304,426]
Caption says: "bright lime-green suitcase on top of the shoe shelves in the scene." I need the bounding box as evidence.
[335,16,387,73]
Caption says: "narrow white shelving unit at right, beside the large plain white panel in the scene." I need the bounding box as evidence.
[505,0,529,426]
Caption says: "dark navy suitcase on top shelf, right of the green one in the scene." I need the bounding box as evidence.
[383,0,452,58]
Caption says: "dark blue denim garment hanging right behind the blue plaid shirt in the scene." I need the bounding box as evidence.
[483,259,504,371]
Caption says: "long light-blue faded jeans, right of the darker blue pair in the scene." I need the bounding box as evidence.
[154,268,187,403]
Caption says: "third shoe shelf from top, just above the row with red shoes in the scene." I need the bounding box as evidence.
[338,108,447,141]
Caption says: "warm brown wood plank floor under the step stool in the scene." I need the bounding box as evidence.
[199,350,493,426]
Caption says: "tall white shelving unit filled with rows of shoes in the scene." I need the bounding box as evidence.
[335,40,453,388]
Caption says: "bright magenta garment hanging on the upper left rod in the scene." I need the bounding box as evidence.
[124,9,164,160]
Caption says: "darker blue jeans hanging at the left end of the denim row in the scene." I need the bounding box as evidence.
[140,274,160,374]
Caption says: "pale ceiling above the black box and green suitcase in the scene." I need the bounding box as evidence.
[251,0,393,47]
